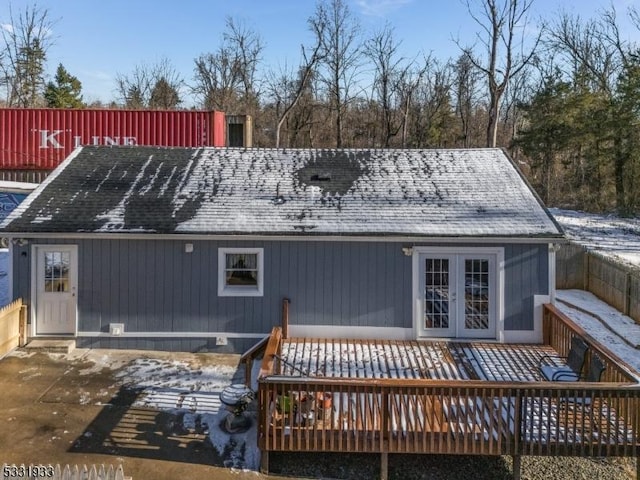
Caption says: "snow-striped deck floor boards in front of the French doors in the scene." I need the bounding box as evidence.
[282,338,560,382]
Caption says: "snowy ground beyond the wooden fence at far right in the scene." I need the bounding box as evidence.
[549,208,640,267]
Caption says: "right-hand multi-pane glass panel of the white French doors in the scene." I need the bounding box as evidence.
[464,258,489,330]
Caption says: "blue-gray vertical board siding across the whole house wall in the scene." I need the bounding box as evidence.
[14,239,549,345]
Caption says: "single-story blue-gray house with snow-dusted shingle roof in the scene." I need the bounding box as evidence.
[0,147,562,351]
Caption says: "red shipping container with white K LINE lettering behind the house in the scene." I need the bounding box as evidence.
[0,108,226,170]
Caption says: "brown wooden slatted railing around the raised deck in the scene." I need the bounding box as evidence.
[258,308,640,457]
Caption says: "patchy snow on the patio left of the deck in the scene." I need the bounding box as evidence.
[73,349,260,471]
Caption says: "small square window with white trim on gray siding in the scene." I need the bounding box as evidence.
[218,248,264,297]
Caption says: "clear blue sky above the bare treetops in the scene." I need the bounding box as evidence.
[0,0,640,105]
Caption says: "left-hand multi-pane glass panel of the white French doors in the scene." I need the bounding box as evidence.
[424,258,449,328]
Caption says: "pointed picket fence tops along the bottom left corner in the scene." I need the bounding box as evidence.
[0,463,131,480]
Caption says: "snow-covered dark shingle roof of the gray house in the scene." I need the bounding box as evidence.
[2,147,561,237]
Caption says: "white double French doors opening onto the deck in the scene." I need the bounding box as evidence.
[414,249,500,339]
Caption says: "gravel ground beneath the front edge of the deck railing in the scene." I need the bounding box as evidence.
[269,453,635,480]
